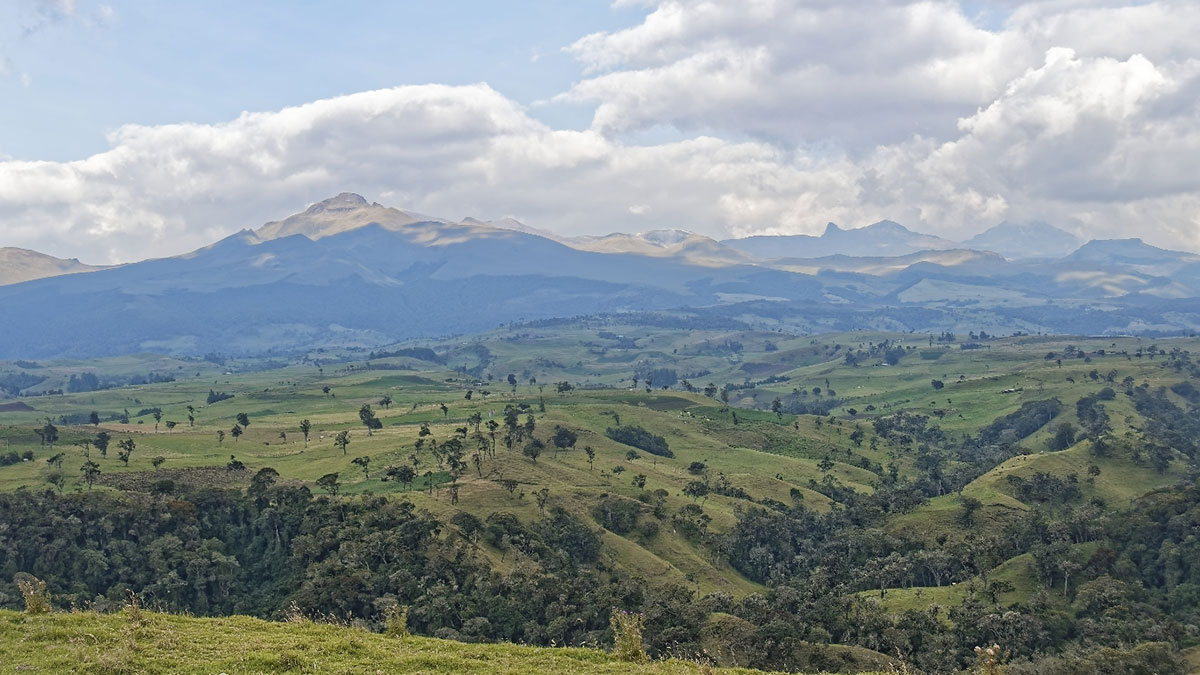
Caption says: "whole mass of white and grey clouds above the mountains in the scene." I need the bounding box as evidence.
[0,0,1200,262]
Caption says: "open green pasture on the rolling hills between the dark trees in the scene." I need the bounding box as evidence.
[0,324,1200,607]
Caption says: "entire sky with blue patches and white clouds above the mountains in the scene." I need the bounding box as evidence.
[0,0,1200,263]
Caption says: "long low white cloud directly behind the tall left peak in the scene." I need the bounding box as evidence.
[0,85,873,262]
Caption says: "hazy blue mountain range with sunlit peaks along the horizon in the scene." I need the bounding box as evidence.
[0,193,1200,358]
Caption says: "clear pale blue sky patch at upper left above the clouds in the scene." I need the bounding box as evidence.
[0,0,647,161]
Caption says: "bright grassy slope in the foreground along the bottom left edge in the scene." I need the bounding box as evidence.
[0,610,844,675]
